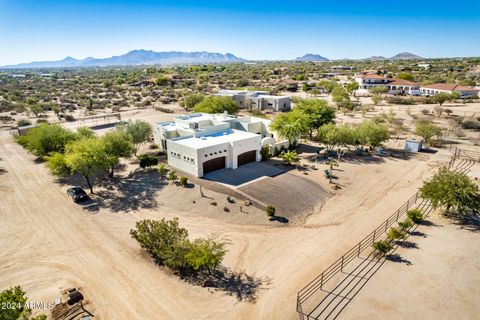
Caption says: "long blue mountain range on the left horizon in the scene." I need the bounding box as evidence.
[1,50,244,68]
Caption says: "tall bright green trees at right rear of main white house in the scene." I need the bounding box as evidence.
[270,99,335,145]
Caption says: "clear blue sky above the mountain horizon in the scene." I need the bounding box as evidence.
[0,0,480,65]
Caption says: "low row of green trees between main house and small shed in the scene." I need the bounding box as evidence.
[317,120,389,151]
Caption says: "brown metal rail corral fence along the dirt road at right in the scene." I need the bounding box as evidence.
[296,148,480,320]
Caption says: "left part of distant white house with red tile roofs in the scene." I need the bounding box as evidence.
[355,73,420,95]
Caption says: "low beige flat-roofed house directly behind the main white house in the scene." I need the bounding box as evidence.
[217,90,292,112]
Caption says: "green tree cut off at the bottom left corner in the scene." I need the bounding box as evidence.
[0,286,47,320]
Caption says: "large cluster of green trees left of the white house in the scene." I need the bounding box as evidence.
[17,120,152,193]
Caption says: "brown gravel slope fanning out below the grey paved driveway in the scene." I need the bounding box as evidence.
[238,172,328,223]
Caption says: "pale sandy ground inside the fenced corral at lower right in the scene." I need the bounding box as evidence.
[341,208,480,320]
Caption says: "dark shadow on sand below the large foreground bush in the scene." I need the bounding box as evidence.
[182,267,271,303]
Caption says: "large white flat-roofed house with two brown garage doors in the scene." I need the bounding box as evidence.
[154,113,289,177]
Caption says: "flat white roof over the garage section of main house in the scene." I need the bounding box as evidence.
[172,129,260,149]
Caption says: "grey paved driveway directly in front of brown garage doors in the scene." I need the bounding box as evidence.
[204,162,285,187]
